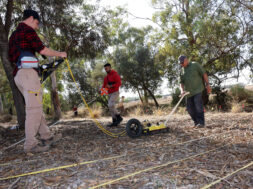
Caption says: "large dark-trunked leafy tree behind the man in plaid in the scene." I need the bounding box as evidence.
[0,0,112,127]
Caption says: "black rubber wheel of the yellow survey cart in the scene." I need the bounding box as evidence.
[126,119,143,138]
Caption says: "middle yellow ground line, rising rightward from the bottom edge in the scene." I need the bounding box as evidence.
[90,143,231,189]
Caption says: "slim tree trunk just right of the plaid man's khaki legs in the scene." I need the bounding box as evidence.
[50,72,61,120]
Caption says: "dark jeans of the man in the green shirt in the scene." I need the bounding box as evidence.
[186,93,205,126]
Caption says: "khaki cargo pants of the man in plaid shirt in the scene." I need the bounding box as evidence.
[14,69,51,150]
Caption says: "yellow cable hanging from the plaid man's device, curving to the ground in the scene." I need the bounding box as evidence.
[65,58,126,137]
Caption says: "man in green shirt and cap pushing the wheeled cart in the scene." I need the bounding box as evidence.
[178,55,211,128]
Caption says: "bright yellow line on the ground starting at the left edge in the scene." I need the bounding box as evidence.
[0,155,125,181]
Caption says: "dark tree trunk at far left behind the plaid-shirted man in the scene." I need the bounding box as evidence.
[0,18,25,129]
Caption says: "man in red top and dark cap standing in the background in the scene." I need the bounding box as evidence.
[103,63,123,127]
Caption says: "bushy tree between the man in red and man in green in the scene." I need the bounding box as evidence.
[114,27,163,107]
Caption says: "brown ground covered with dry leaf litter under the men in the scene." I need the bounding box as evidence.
[0,113,253,189]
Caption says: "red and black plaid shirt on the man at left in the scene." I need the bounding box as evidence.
[9,22,45,63]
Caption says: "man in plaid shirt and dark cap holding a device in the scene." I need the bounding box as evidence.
[9,9,67,152]
